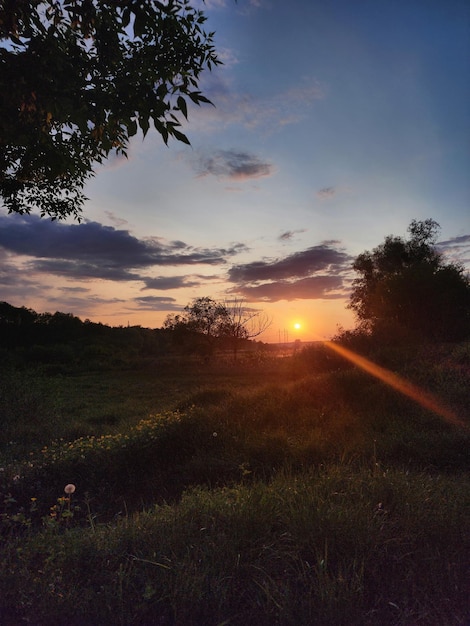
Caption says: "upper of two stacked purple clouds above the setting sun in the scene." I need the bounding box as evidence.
[228,244,351,284]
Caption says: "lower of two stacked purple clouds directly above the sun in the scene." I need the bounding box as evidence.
[232,276,346,302]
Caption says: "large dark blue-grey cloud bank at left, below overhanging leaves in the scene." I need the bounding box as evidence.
[0,215,246,281]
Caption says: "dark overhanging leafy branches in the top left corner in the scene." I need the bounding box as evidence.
[0,0,219,219]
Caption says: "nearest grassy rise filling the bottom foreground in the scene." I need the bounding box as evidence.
[0,466,470,626]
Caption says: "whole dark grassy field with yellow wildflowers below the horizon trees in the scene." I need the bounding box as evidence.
[0,346,470,626]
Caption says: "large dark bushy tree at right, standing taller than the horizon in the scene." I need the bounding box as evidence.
[349,219,470,342]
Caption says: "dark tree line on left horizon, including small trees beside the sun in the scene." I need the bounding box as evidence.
[0,297,269,371]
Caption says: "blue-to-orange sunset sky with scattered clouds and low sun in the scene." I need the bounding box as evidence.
[0,0,470,342]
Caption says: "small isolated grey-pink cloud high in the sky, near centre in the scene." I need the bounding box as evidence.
[198,150,273,181]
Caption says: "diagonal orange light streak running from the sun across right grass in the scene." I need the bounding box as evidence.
[324,341,469,429]
